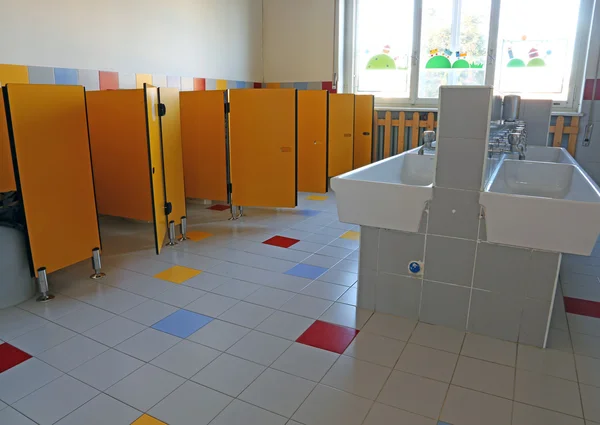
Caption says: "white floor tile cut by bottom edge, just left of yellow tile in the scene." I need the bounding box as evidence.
[57,394,140,425]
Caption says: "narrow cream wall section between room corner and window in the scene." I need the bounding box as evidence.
[263,0,335,83]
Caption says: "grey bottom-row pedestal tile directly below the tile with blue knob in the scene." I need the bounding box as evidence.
[378,273,422,319]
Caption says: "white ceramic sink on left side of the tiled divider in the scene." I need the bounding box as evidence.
[331,149,435,232]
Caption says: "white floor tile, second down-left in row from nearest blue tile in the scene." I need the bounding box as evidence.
[69,349,144,391]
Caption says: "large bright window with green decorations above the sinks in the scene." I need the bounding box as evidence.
[340,0,593,109]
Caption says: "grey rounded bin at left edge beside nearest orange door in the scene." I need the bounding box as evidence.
[0,226,35,308]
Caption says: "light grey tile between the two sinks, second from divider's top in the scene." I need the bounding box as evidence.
[435,137,487,191]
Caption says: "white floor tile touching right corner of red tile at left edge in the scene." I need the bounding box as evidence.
[38,335,108,372]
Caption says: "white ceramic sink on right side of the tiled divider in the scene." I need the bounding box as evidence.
[479,158,600,255]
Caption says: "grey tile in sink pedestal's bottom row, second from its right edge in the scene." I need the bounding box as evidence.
[467,289,522,342]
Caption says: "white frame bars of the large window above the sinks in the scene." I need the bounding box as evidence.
[336,0,594,113]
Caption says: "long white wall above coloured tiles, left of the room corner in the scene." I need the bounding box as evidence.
[0,0,262,81]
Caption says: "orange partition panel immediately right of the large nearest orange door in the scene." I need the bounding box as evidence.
[87,90,153,221]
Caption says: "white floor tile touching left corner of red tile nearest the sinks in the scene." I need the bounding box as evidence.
[227,331,292,366]
